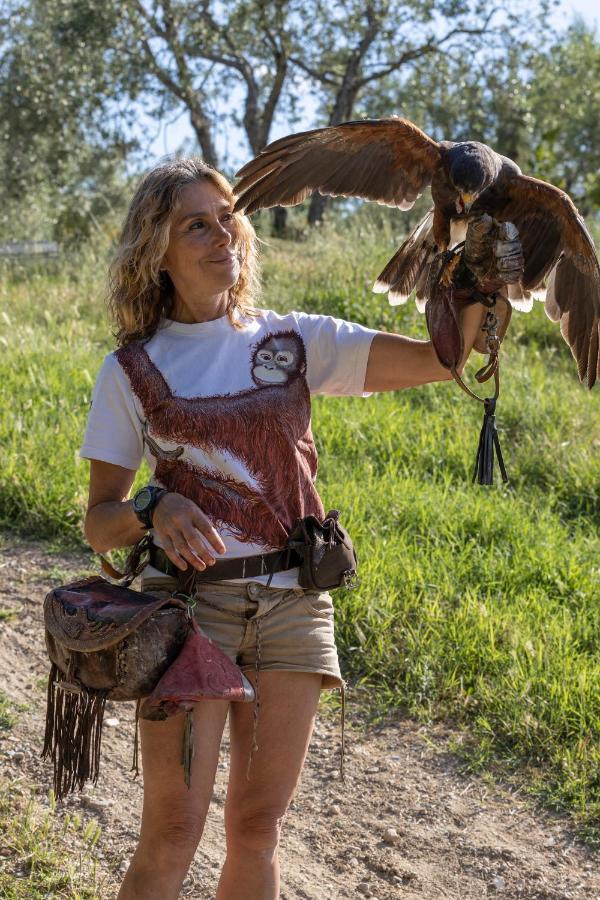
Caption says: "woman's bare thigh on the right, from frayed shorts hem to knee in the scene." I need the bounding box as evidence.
[225,671,322,840]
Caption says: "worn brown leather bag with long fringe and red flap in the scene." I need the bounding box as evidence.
[42,576,254,798]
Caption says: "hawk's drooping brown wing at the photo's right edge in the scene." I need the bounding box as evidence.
[489,175,600,388]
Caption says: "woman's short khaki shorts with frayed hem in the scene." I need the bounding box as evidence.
[142,575,343,690]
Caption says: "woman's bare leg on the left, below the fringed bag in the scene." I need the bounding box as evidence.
[118,700,229,900]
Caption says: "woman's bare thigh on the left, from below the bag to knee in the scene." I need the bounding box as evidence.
[140,700,229,842]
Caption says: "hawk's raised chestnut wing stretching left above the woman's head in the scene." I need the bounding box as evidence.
[235,117,440,213]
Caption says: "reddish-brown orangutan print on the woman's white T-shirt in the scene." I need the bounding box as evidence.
[116,331,324,548]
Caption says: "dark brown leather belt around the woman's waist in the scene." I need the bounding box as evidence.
[149,545,301,584]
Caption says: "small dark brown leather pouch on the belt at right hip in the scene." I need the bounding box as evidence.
[287,509,358,591]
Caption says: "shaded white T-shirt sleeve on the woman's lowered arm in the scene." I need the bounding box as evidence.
[79,353,144,470]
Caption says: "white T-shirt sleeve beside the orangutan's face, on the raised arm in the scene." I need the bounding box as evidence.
[297,313,377,397]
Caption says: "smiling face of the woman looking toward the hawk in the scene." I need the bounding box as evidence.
[162,179,241,300]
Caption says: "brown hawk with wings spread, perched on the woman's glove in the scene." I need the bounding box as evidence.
[235,117,600,388]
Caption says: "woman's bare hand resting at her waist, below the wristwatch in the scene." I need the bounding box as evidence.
[152,491,225,572]
